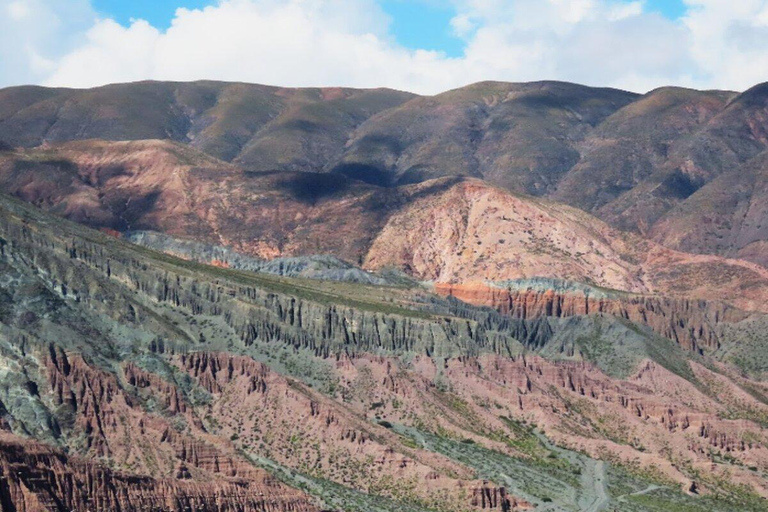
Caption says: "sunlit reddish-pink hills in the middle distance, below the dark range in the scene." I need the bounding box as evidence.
[6,141,768,316]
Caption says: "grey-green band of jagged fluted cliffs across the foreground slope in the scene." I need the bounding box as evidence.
[0,190,512,357]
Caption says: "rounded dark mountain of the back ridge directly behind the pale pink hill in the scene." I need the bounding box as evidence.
[339,82,636,190]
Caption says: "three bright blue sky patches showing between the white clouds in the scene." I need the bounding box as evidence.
[93,0,685,57]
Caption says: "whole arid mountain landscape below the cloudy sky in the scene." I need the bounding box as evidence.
[0,78,768,512]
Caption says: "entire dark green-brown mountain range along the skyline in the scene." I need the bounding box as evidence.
[0,82,768,265]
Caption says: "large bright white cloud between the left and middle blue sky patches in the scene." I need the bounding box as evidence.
[46,0,464,90]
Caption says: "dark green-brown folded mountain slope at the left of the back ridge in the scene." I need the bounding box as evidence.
[0,82,413,165]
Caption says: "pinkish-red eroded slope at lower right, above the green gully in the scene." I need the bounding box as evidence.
[332,356,768,496]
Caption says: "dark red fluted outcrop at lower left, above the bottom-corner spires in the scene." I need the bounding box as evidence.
[44,347,296,480]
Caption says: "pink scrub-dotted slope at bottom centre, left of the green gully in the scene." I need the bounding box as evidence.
[170,352,536,510]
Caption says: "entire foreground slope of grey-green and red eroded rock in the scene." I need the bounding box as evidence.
[0,189,768,511]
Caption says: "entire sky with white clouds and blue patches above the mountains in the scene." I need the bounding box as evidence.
[0,0,768,94]
